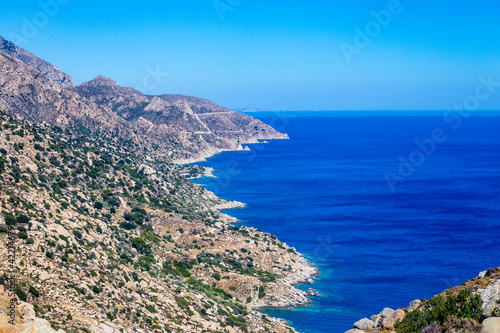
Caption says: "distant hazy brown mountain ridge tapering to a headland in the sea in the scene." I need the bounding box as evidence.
[0,35,287,162]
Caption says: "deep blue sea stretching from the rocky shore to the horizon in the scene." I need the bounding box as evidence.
[191,113,500,333]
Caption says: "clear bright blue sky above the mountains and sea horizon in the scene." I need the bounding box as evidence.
[0,0,500,110]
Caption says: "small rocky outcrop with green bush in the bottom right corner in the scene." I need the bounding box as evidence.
[346,267,500,333]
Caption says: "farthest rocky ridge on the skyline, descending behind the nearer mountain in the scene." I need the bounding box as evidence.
[0,36,75,88]
